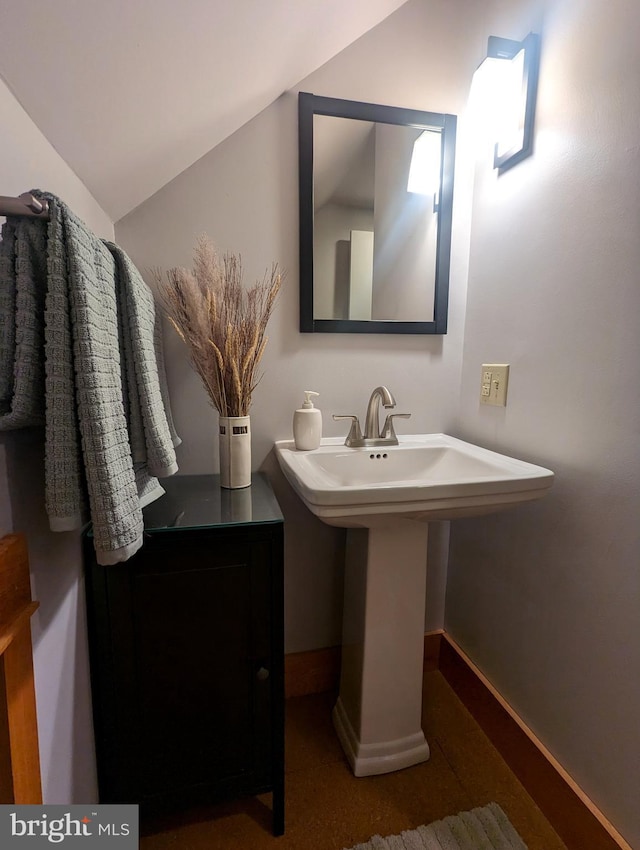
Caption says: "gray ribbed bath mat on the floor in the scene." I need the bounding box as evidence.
[342,803,527,850]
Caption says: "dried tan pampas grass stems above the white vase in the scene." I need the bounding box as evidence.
[154,235,282,416]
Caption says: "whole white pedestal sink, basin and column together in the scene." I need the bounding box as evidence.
[275,434,553,776]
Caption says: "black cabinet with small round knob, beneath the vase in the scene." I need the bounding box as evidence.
[84,474,284,834]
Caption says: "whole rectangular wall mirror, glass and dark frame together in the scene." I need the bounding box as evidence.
[298,92,456,334]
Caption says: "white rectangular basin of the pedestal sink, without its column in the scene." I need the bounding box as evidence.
[276,434,553,528]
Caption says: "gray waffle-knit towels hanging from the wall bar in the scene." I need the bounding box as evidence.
[0,190,179,564]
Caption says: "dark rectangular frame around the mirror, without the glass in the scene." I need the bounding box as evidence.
[298,92,457,334]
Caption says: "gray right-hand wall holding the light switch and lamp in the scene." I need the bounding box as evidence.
[446,0,640,847]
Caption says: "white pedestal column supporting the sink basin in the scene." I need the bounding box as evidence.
[333,520,429,776]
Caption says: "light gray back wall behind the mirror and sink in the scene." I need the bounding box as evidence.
[116,0,482,652]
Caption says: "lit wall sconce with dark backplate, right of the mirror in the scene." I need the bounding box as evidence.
[476,33,540,174]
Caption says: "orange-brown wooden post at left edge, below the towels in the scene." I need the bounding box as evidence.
[0,534,42,805]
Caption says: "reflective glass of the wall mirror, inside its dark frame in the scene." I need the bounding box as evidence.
[313,115,441,322]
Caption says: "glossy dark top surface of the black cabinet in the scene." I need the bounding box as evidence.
[143,473,283,531]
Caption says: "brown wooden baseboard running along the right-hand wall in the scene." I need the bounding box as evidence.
[440,633,632,850]
